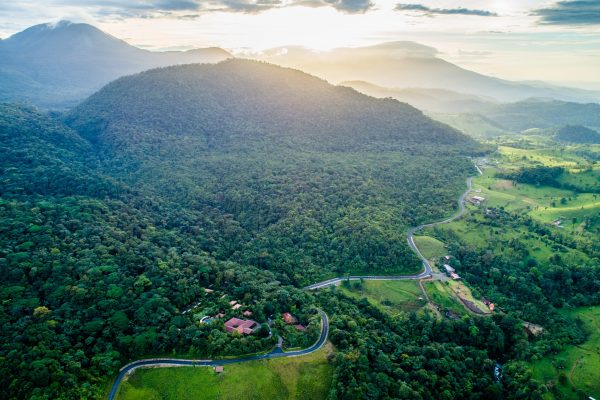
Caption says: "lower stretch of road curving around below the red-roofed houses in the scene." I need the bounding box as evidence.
[108,310,329,400]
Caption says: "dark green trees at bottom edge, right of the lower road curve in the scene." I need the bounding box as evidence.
[321,293,543,400]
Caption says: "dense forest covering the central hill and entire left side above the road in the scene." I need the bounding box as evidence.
[0,61,488,399]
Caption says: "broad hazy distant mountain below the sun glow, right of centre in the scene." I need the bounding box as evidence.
[258,42,600,102]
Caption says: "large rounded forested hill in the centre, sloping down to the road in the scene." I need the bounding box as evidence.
[67,60,477,284]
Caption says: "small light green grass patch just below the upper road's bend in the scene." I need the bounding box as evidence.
[340,281,426,313]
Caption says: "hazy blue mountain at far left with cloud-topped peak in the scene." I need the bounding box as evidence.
[0,21,231,108]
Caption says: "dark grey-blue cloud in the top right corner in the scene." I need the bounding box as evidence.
[533,0,600,25]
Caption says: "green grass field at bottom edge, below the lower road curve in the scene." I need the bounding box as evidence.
[117,343,333,400]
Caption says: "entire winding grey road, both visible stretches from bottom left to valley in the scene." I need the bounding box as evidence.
[108,165,482,400]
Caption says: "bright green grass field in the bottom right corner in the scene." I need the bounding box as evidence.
[531,307,600,399]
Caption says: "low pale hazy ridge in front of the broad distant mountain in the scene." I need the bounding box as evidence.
[340,81,496,113]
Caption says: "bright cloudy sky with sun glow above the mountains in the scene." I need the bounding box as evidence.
[0,0,600,89]
